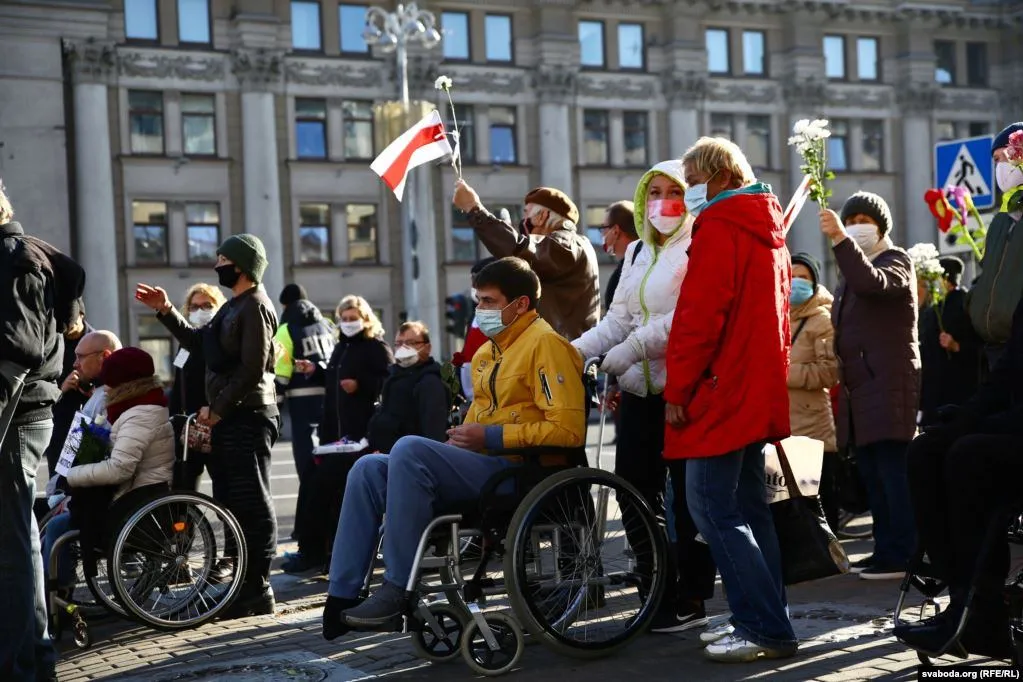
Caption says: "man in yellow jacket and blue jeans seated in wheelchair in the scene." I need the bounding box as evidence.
[323,258,586,639]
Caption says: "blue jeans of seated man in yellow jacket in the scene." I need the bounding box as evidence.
[327,436,515,599]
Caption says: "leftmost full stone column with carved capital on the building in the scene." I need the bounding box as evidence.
[63,40,122,335]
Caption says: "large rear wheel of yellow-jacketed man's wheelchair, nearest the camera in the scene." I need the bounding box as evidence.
[504,468,668,658]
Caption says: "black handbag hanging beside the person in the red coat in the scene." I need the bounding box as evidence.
[770,443,849,585]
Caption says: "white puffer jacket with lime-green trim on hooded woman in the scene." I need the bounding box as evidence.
[572,161,693,397]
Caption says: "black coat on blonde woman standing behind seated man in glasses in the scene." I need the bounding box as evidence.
[316,334,394,443]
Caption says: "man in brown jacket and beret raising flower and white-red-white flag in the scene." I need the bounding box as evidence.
[454,180,601,340]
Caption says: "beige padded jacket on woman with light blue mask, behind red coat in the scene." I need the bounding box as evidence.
[789,284,838,452]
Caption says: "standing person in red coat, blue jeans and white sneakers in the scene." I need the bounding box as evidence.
[664,137,797,662]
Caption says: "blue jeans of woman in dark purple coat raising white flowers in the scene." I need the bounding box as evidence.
[856,441,917,569]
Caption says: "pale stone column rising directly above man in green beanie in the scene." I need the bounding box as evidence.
[231,50,286,301]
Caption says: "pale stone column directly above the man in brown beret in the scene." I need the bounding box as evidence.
[534,66,577,196]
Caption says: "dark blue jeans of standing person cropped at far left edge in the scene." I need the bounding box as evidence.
[0,419,56,682]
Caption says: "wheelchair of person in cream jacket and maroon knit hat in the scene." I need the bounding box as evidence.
[40,414,247,648]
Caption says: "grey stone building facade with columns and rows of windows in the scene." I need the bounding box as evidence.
[0,0,1023,373]
